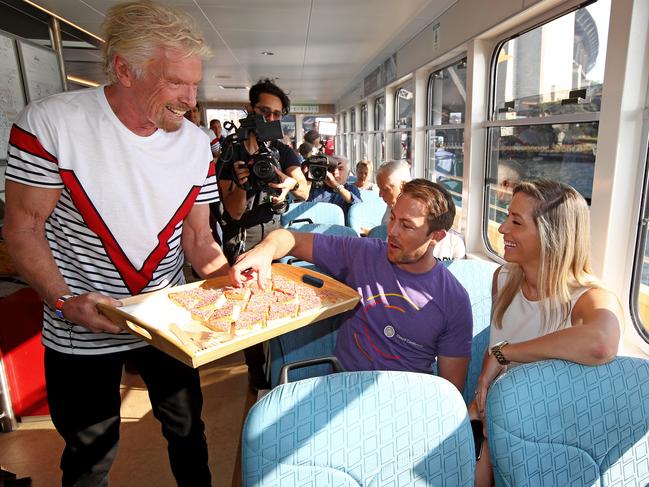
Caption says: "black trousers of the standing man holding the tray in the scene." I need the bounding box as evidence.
[45,346,211,487]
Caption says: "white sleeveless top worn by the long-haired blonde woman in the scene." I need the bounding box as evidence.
[489,264,590,354]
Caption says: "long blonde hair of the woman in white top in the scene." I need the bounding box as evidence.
[493,179,603,333]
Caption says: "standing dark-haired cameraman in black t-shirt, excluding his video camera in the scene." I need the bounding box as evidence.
[217,79,309,263]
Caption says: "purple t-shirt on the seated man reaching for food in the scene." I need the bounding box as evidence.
[313,234,473,373]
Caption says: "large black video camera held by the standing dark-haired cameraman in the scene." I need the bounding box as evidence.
[221,113,283,194]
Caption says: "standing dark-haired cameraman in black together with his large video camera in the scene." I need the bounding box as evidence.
[217,79,309,390]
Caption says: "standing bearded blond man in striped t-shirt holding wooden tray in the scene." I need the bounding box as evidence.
[4,2,228,486]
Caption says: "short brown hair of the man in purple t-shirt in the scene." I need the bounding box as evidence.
[399,178,455,234]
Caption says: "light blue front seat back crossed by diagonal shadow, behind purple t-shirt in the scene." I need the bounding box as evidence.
[241,371,475,487]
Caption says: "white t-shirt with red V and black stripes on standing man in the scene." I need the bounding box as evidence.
[6,87,218,354]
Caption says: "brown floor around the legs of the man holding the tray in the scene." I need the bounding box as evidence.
[0,352,256,487]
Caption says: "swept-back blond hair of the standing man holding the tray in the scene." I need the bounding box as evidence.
[102,0,212,83]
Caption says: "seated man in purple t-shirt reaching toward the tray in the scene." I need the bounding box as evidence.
[230,179,473,391]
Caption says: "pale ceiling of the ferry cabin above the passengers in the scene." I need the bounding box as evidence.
[20,0,455,103]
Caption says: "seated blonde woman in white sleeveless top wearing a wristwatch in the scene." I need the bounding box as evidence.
[469,180,622,486]
